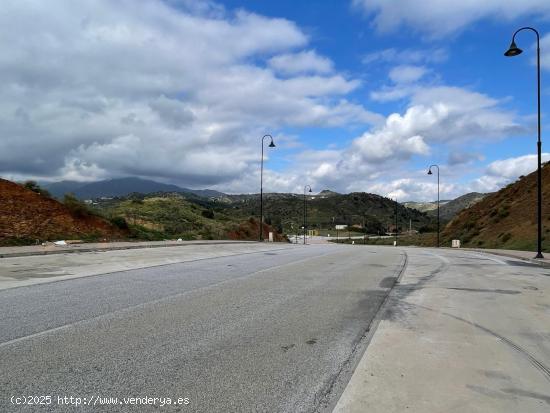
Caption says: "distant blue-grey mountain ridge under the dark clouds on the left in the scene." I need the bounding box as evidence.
[42,177,224,199]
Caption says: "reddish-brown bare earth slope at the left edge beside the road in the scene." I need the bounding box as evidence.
[0,179,124,245]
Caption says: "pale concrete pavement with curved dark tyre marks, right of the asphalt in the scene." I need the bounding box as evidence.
[334,248,550,413]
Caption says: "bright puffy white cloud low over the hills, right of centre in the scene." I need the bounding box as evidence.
[250,86,525,200]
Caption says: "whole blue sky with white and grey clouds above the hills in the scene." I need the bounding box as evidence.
[0,0,550,201]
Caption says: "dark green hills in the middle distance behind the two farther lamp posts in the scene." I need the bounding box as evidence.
[214,191,433,234]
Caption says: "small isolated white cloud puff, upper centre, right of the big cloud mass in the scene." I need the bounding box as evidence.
[269,50,334,75]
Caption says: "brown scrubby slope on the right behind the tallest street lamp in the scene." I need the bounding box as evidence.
[443,164,550,251]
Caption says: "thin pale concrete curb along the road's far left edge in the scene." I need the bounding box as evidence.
[0,240,257,258]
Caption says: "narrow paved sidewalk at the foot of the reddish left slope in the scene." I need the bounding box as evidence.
[0,240,255,258]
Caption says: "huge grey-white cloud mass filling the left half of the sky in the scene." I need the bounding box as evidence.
[0,0,381,186]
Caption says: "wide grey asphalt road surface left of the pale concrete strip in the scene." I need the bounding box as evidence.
[0,245,403,412]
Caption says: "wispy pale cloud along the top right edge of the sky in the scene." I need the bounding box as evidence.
[352,0,550,37]
